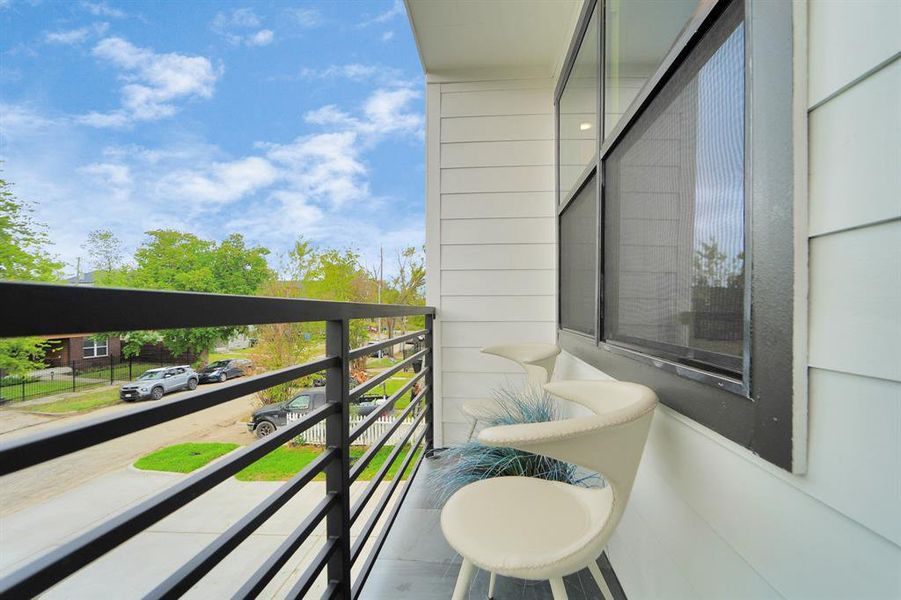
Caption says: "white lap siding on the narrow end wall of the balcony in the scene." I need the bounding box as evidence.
[426,79,556,445]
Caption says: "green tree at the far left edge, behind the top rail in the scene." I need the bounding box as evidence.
[0,179,63,375]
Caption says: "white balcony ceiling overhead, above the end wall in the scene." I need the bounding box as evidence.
[405,0,582,77]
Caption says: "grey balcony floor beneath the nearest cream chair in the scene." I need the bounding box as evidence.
[361,457,625,600]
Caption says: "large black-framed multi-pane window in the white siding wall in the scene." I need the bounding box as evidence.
[555,0,806,469]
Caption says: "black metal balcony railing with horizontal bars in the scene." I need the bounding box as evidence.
[0,283,435,599]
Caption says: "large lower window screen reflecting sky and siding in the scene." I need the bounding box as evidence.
[604,3,744,375]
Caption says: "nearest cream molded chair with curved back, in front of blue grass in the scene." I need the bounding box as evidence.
[441,381,657,600]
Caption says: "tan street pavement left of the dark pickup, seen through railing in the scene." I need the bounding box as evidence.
[0,384,254,516]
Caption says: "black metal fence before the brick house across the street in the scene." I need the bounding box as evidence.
[0,353,193,404]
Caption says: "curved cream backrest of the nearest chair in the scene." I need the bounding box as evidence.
[479,381,657,506]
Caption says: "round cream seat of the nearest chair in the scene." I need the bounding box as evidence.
[441,477,613,579]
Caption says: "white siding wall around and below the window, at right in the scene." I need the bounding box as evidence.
[557,0,901,600]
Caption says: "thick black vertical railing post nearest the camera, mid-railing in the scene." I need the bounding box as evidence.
[325,319,351,600]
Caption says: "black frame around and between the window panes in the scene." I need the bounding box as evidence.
[554,0,806,472]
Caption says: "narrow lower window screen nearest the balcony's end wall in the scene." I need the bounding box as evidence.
[560,175,598,336]
